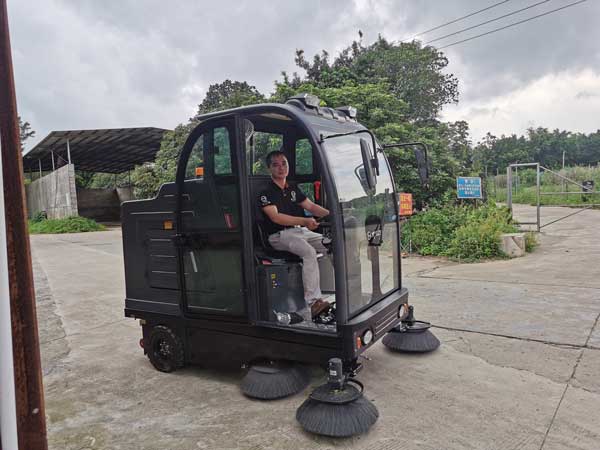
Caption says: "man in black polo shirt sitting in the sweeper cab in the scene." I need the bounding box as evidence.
[259,150,329,318]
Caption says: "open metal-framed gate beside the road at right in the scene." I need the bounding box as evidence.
[506,163,600,231]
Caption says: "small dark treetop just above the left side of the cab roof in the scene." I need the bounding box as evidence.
[197,80,264,116]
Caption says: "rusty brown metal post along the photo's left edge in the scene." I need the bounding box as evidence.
[0,0,48,450]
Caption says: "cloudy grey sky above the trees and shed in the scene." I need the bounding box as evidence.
[8,0,600,149]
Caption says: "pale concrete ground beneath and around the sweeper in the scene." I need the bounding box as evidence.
[31,207,600,450]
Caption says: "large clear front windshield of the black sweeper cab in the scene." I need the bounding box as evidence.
[323,133,400,316]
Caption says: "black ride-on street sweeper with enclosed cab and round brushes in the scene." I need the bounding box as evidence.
[122,94,439,436]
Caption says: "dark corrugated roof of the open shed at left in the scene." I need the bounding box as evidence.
[23,127,168,173]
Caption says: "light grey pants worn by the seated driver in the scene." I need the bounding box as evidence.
[269,227,327,305]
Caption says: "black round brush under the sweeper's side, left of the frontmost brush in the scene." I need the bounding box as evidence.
[241,361,310,400]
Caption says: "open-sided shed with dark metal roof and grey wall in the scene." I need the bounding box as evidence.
[23,127,168,221]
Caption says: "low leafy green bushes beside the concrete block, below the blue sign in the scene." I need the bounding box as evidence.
[402,203,517,261]
